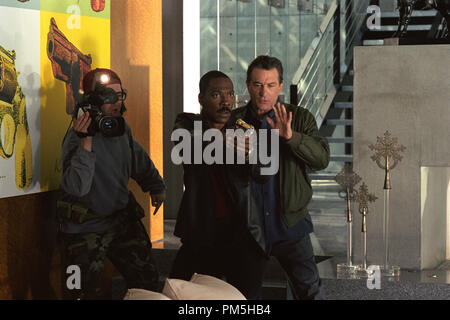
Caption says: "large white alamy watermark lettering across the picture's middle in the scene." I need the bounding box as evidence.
[170,121,280,175]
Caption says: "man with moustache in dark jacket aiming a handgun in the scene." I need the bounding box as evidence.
[170,71,266,299]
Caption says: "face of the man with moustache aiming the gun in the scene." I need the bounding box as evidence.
[198,78,234,125]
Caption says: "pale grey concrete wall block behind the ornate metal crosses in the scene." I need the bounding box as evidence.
[354,45,450,269]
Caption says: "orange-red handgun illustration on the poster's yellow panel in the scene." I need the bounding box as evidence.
[47,18,92,114]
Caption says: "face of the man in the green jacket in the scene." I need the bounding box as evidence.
[247,68,284,117]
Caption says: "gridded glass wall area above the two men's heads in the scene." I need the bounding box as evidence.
[200,0,338,100]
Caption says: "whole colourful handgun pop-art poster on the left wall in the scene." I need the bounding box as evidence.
[0,0,110,198]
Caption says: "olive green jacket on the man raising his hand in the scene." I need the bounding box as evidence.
[233,101,330,227]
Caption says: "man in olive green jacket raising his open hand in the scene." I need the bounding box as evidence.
[233,56,330,299]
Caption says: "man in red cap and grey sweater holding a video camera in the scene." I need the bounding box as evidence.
[58,69,165,299]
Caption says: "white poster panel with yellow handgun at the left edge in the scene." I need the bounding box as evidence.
[0,0,40,198]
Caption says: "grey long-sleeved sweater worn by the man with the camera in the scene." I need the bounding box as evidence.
[61,124,165,233]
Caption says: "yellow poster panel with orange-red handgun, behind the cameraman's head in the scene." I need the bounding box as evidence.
[41,9,110,191]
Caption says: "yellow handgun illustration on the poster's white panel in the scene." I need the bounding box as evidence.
[0,46,33,190]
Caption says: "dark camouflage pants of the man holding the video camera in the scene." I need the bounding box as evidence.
[62,221,159,299]
